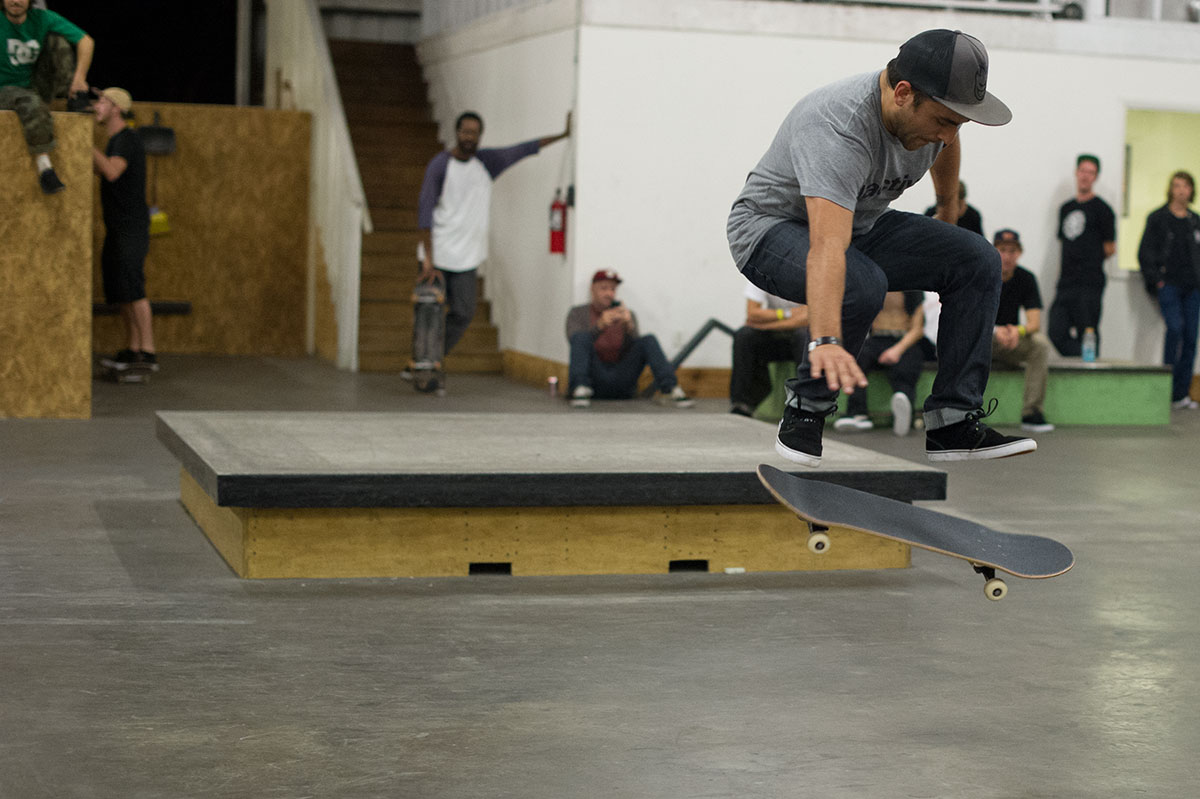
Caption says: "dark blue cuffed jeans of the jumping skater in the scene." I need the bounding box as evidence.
[742,211,1000,429]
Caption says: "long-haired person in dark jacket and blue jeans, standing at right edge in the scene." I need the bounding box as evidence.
[1138,172,1200,409]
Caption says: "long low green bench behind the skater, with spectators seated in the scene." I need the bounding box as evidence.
[755,360,1171,426]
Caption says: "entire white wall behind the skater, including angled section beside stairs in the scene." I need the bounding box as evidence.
[428,0,1200,367]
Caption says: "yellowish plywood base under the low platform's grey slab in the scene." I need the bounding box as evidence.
[180,470,911,578]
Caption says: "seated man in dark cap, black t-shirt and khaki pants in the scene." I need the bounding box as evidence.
[991,229,1054,433]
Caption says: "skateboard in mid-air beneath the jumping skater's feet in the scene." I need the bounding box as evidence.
[758,464,1075,600]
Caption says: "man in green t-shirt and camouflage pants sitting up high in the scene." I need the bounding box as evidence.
[0,0,95,194]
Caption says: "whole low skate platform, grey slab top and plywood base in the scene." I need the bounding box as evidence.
[158,411,946,578]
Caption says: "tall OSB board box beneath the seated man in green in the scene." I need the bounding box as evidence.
[0,112,95,419]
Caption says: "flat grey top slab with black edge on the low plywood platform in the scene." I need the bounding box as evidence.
[157,411,946,507]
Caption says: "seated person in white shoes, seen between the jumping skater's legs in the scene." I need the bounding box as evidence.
[833,292,925,435]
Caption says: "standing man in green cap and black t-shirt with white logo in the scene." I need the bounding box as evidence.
[1048,154,1117,356]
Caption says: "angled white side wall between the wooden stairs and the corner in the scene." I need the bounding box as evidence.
[418,0,576,361]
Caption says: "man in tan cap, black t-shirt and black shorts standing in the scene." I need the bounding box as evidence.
[92,88,158,371]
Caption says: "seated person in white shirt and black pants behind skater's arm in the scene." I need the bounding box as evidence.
[730,281,809,416]
